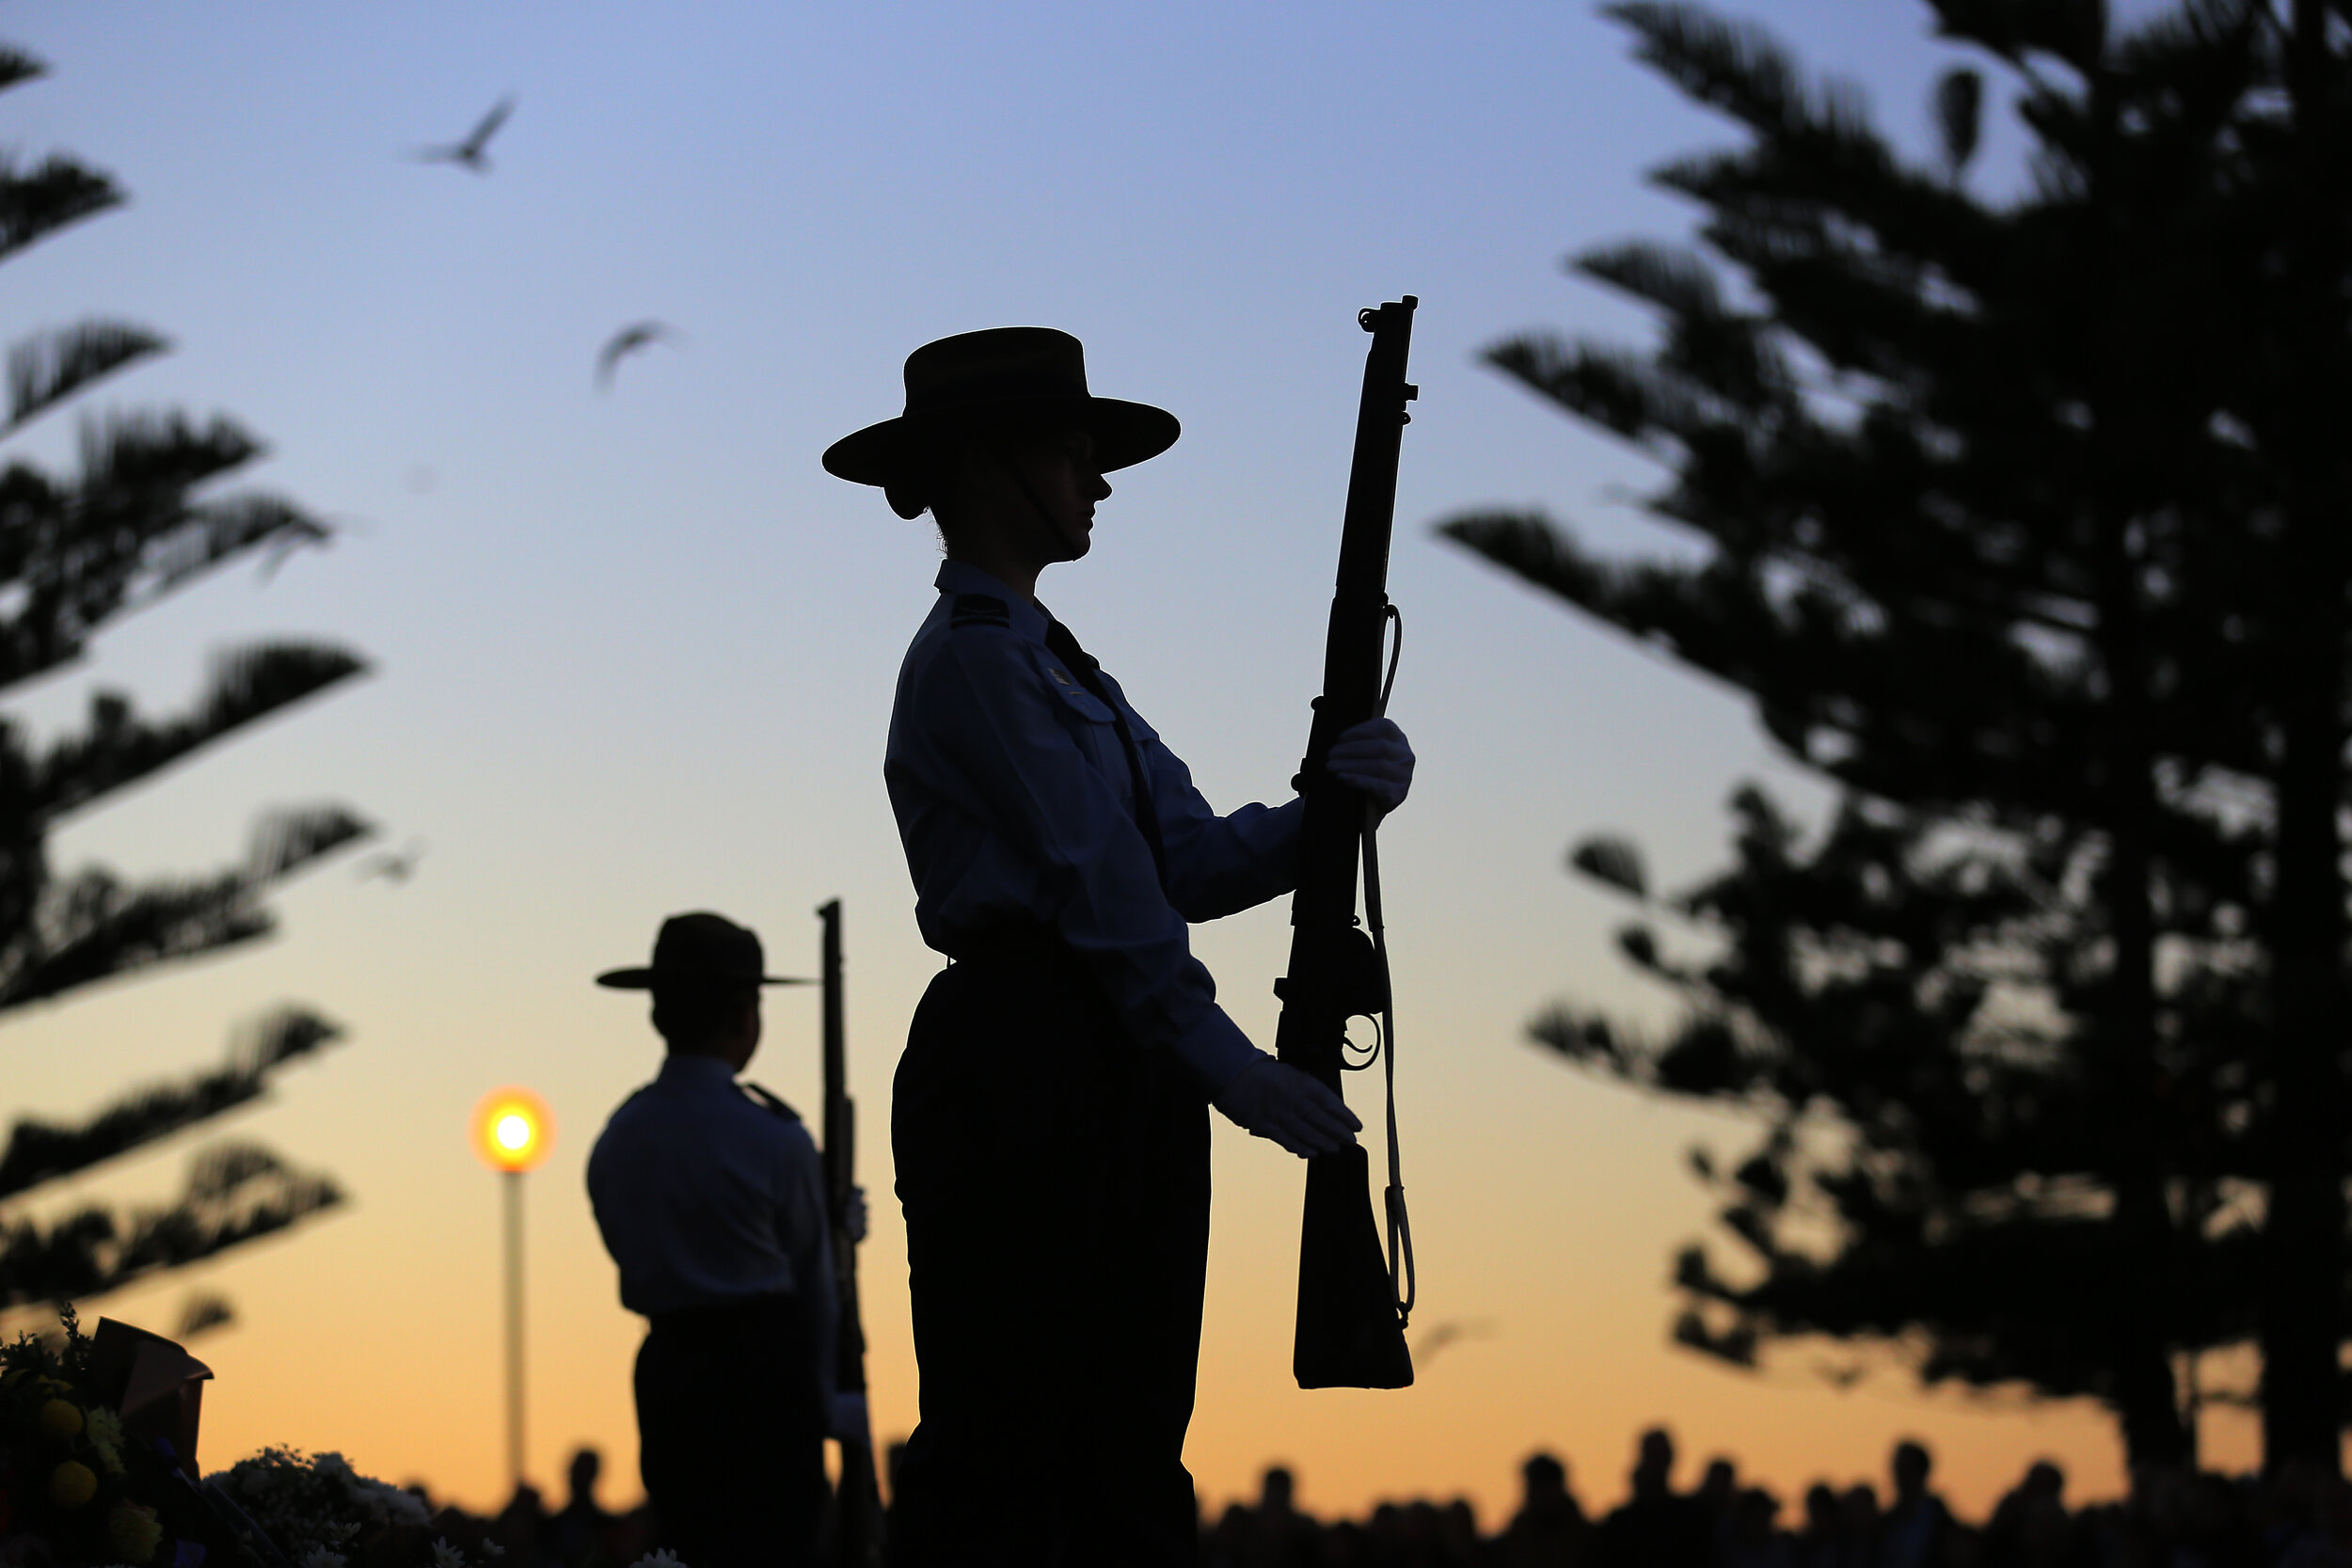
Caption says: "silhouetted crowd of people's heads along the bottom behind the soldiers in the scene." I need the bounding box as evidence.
[414,1427,2352,1568]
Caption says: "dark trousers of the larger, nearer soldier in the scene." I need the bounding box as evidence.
[892,947,1209,1568]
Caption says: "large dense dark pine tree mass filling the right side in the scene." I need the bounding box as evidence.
[1444,0,2347,1465]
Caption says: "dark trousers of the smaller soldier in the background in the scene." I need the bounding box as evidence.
[638,1295,826,1568]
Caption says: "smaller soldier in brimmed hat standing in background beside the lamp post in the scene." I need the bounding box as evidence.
[588,914,866,1568]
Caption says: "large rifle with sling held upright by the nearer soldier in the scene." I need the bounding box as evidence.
[1275,293,1421,1389]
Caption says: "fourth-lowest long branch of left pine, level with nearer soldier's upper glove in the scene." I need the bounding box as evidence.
[22,641,367,823]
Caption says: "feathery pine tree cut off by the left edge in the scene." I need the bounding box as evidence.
[0,47,370,1328]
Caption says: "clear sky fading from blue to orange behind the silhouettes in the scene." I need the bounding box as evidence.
[0,0,2251,1524]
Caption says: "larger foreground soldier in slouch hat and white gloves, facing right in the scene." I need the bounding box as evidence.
[826,326,1411,1563]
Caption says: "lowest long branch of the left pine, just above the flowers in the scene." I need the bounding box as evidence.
[0,1143,343,1309]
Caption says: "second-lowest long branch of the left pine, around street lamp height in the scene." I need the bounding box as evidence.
[0,1008,343,1199]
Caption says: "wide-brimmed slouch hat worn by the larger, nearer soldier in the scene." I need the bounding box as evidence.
[826,326,1184,515]
